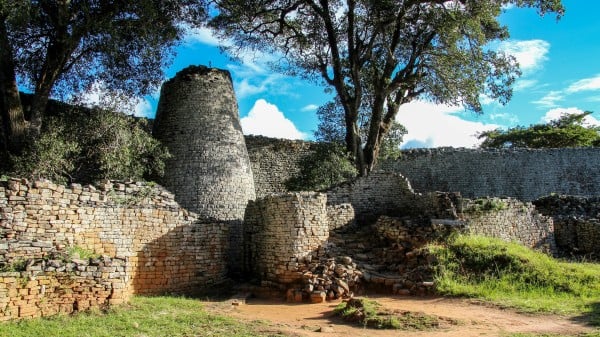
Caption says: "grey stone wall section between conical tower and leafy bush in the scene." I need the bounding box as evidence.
[246,136,314,198]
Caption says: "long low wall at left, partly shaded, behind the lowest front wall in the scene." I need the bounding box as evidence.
[0,179,229,318]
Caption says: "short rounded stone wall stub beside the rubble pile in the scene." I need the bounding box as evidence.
[244,192,329,284]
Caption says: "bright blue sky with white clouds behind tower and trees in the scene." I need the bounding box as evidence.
[138,0,600,147]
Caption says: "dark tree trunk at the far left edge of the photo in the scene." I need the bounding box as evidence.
[0,18,27,153]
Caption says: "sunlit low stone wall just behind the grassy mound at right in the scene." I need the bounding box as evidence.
[461,198,558,254]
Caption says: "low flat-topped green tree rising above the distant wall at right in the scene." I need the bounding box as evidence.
[477,111,600,148]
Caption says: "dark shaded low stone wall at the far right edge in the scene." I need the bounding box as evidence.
[533,195,600,259]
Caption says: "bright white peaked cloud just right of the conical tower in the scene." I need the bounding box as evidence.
[241,99,306,139]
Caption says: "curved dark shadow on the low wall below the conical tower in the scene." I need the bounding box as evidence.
[129,222,229,295]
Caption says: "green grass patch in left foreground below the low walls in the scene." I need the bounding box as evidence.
[0,297,282,337]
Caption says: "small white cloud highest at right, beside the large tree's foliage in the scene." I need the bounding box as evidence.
[498,40,550,73]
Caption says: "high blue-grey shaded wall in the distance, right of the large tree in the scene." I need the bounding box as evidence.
[380,148,600,201]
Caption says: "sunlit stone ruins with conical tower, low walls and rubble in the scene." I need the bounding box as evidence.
[0,66,597,321]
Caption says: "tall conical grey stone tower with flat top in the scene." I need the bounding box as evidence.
[153,66,255,269]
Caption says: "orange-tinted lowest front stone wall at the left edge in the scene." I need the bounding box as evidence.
[0,256,127,321]
